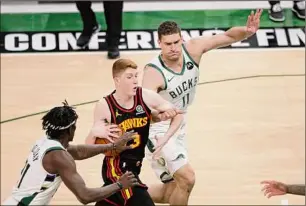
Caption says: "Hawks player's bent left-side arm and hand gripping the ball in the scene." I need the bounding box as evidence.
[85,99,121,144]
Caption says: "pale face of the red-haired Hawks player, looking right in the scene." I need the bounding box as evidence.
[117,68,138,96]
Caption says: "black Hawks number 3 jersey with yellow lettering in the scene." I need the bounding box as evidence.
[105,87,151,160]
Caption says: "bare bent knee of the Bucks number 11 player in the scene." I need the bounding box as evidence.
[175,166,195,192]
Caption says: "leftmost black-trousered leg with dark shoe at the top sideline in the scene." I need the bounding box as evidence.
[76,1,100,47]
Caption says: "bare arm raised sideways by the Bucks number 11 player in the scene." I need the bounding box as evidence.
[186,9,262,55]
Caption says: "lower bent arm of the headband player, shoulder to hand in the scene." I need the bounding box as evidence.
[43,150,138,204]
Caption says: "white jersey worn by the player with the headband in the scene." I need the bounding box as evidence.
[12,137,65,205]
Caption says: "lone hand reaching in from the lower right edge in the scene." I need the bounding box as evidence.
[261,180,287,198]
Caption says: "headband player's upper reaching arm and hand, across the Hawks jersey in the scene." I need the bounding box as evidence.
[67,132,135,160]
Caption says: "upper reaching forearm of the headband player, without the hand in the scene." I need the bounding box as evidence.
[67,144,113,160]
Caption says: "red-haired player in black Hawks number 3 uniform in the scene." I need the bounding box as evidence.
[86,59,183,206]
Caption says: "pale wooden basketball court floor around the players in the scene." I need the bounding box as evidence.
[1,49,305,205]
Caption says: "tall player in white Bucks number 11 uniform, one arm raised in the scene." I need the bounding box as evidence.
[142,10,262,205]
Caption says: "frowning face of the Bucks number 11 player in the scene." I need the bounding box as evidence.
[159,33,183,61]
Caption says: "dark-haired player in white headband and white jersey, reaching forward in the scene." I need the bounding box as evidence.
[2,102,138,206]
